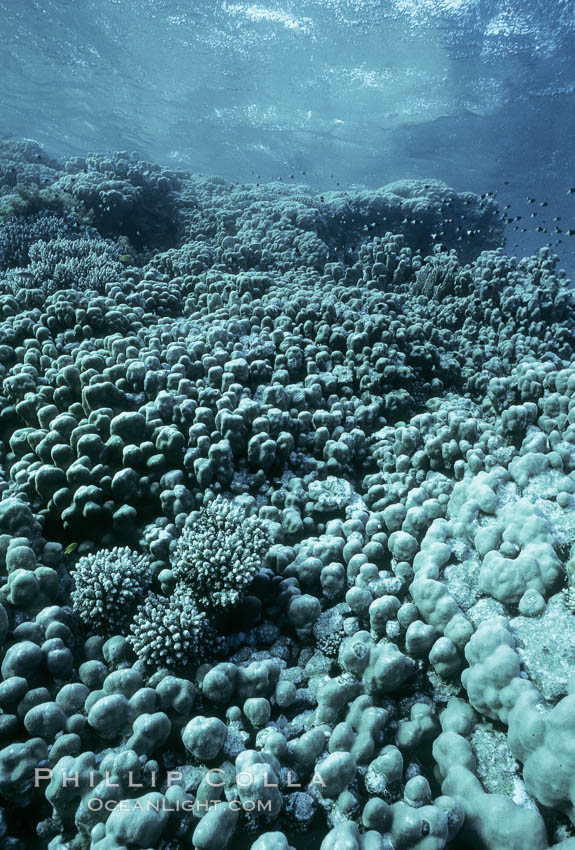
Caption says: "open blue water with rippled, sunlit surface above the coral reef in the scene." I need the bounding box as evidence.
[0,0,575,266]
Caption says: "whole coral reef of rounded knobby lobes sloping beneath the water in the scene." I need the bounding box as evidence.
[0,141,575,850]
